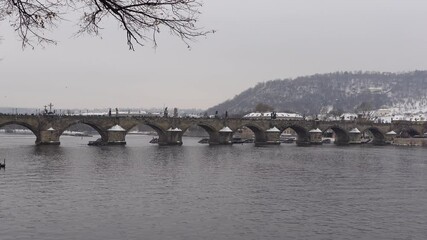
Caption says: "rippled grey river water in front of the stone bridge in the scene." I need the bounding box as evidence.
[0,134,427,240]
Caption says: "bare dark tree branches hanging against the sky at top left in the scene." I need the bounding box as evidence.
[0,0,213,50]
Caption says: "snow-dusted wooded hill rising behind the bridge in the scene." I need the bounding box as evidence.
[207,71,427,115]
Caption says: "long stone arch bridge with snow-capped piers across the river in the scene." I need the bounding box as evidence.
[0,115,427,146]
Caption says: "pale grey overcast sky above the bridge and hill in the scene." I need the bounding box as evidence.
[0,0,427,109]
